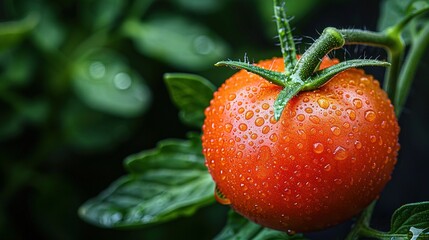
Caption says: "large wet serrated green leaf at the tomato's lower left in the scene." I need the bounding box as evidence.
[79,137,214,228]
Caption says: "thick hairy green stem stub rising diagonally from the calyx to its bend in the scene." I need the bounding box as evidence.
[292,27,345,82]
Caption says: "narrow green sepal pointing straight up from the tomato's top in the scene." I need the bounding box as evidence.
[273,0,296,75]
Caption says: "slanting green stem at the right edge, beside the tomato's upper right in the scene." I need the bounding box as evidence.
[394,25,429,116]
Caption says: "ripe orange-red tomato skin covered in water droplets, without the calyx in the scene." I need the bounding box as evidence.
[202,58,399,232]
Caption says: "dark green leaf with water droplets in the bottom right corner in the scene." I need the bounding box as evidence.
[389,202,429,236]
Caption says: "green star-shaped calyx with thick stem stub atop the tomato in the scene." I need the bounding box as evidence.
[215,26,390,121]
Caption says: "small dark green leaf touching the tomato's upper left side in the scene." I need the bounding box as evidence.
[164,73,216,128]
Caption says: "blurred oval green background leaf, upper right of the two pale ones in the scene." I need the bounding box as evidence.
[123,14,228,71]
